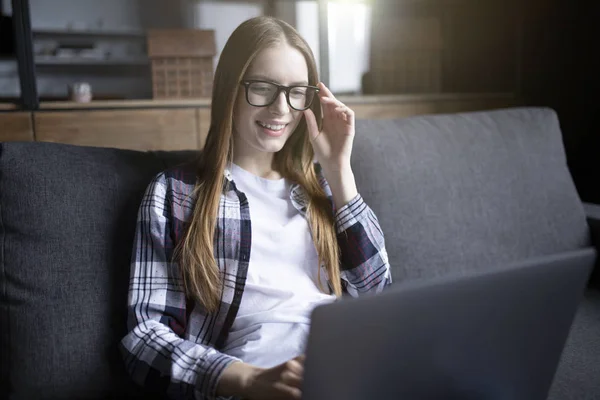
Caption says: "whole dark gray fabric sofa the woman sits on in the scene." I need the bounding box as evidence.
[0,109,600,399]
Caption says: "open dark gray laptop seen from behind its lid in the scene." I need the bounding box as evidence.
[303,249,596,400]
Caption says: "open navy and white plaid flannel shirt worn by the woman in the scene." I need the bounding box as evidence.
[120,161,391,399]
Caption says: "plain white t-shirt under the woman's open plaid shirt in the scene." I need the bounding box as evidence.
[223,165,335,367]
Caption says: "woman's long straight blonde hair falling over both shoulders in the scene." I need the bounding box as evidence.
[175,17,342,312]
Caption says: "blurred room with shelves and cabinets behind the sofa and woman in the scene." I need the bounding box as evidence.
[0,0,600,203]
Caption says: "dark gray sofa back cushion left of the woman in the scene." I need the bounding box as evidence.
[0,143,192,399]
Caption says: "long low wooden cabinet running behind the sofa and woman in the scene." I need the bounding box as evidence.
[0,93,520,151]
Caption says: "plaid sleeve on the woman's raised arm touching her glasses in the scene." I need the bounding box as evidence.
[335,194,392,297]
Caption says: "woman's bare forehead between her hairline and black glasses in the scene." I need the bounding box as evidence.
[246,43,308,85]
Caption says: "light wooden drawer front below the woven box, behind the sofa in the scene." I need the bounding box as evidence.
[35,109,198,150]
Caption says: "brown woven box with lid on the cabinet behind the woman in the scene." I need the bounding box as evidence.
[148,29,216,99]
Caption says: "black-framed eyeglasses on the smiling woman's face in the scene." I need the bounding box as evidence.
[240,80,319,111]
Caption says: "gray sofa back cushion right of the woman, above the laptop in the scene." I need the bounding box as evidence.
[353,108,589,283]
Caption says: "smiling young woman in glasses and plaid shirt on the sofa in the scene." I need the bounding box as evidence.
[121,17,391,400]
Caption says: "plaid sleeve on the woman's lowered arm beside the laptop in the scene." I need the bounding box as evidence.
[120,174,237,399]
